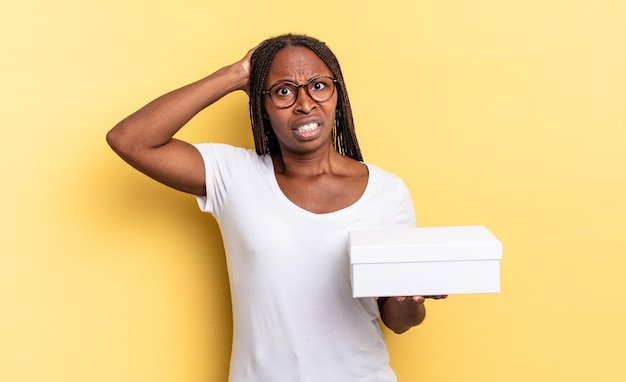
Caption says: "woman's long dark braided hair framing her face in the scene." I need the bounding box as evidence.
[249,34,363,161]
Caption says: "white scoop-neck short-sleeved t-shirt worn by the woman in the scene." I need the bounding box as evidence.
[196,143,415,382]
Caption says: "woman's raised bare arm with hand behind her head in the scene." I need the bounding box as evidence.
[106,50,253,195]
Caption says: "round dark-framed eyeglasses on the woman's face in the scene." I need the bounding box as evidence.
[263,76,337,109]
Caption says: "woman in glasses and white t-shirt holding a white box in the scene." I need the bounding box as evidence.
[107,35,438,382]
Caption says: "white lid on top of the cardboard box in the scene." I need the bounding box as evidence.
[349,226,502,264]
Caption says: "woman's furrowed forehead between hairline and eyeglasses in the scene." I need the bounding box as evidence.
[265,46,332,84]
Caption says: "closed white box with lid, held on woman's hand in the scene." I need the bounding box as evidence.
[350,226,502,298]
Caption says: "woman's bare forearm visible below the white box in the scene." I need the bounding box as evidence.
[379,297,426,334]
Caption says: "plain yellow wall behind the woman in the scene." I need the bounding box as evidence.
[0,0,626,382]
